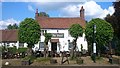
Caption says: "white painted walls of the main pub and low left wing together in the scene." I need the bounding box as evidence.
[0,29,88,52]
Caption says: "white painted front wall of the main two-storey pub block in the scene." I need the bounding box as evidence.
[35,29,88,52]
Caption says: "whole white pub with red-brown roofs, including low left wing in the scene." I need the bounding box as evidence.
[0,6,88,53]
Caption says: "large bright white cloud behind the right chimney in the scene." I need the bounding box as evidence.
[59,1,114,21]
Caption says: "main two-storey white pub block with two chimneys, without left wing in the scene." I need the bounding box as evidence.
[35,6,88,53]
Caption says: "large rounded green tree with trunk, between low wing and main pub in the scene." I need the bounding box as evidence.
[19,18,41,55]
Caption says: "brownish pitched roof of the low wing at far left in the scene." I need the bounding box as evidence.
[0,29,18,42]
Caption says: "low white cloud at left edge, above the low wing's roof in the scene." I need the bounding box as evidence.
[0,18,20,29]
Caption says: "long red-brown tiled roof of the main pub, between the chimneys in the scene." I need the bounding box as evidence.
[36,17,85,28]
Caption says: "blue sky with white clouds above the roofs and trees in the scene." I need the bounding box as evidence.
[0,0,114,29]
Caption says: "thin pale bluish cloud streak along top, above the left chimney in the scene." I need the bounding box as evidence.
[34,2,82,11]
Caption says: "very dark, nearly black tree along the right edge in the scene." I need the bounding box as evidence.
[105,1,120,55]
